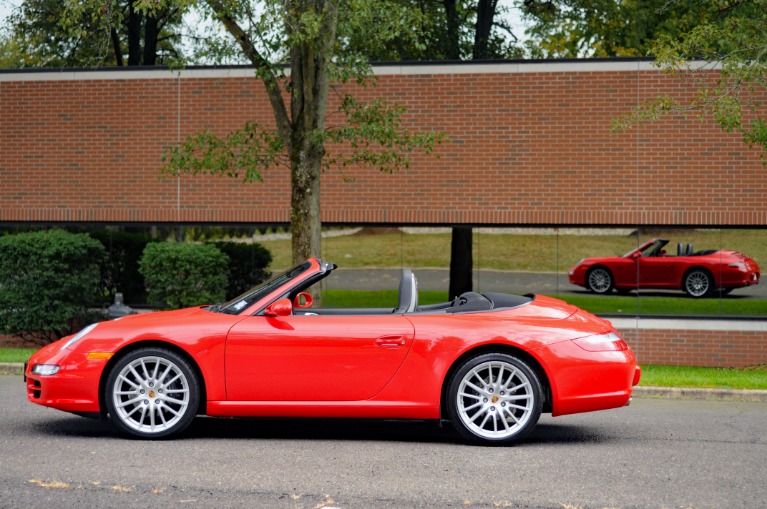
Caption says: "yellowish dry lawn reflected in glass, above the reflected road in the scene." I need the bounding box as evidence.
[260,228,767,272]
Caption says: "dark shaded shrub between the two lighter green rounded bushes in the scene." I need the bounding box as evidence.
[88,230,153,305]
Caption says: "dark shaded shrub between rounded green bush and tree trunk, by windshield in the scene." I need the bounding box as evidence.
[213,242,272,299]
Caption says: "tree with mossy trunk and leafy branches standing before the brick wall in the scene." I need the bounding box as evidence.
[114,0,440,261]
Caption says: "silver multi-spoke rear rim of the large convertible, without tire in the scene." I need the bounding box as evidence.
[456,360,535,440]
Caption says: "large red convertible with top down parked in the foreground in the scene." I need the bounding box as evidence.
[25,259,641,443]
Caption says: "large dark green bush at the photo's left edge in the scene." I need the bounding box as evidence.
[0,230,104,344]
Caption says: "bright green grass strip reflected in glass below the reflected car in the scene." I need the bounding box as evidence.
[322,290,767,317]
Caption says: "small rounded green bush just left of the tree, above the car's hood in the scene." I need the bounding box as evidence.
[139,242,229,309]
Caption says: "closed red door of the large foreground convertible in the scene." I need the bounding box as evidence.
[226,315,414,401]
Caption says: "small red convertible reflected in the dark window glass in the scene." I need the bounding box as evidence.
[568,239,760,297]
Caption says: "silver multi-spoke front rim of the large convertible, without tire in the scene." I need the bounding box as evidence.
[112,356,190,435]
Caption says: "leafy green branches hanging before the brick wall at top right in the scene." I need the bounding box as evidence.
[614,0,767,164]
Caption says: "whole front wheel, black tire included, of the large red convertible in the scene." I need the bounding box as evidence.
[104,348,200,438]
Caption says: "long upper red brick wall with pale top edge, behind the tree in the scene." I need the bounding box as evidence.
[0,61,767,226]
